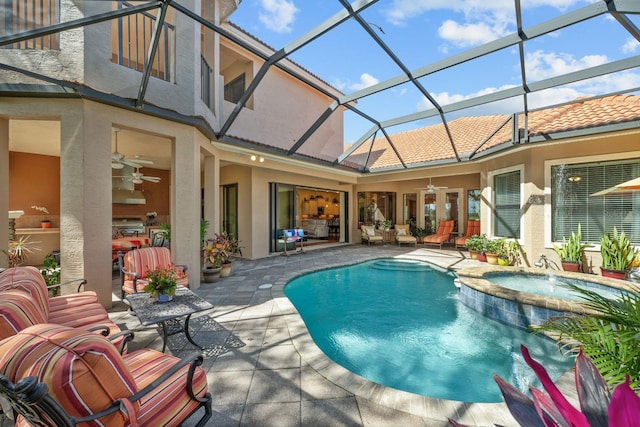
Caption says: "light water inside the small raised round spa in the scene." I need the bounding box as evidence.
[484,273,621,301]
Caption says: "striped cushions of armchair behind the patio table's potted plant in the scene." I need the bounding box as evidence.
[122,247,189,294]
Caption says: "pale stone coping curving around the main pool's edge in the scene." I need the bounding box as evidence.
[271,255,577,426]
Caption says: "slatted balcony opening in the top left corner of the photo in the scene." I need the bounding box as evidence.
[0,0,60,50]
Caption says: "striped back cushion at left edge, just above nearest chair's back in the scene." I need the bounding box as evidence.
[0,289,47,339]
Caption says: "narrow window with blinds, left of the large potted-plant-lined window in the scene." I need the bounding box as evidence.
[493,170,520,239]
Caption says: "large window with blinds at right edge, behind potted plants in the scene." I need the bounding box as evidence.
[551,159,640,245]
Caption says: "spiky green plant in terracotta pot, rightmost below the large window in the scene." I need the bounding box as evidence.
[600,227,640,280]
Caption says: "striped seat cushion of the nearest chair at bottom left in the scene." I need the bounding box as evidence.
[123,348,207,426]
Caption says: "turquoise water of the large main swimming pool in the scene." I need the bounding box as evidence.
[285,259,573,402]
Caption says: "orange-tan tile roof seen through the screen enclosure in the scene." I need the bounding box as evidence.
[345,95,640,170]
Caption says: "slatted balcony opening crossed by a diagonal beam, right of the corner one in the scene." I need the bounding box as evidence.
[111,1,175,81]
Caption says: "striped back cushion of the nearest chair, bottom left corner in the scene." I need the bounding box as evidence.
[0,324,138,426]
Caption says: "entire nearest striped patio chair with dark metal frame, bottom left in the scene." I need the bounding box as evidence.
[0,324,212,427]
